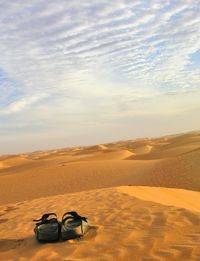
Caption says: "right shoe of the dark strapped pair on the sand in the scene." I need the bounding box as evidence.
[61,211,89,240]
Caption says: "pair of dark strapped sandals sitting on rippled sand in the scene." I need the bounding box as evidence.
[33,211,89,242]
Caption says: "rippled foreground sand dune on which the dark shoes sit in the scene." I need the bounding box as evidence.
[0,187,200,261]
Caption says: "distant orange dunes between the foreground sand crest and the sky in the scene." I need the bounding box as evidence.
[0,129,200,204]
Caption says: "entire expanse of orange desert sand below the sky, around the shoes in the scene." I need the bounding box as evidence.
[0,132,200,261]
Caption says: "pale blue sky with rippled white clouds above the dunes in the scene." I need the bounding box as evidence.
[0,0,200,154]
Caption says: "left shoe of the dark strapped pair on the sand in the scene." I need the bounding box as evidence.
[33,213,60,242]
